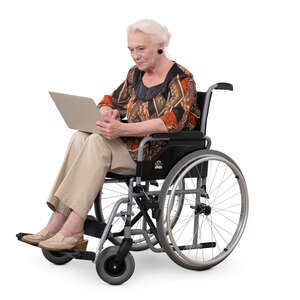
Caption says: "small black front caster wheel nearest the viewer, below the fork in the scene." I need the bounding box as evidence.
[96,246,135,285]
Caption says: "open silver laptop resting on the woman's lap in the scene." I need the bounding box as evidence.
[49,92,100,134]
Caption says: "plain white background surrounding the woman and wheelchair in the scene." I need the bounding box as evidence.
[0,0,300,299]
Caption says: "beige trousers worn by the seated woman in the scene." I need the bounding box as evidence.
[47,131,136,219]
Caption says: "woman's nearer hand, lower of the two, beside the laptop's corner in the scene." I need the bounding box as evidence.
[96,116,122,140]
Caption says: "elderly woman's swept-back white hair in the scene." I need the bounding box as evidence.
[127,19,171,47]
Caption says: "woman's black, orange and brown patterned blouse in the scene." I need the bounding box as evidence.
[98,62,200,161]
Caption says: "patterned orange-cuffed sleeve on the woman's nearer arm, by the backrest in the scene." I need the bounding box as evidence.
[160,76,197,133]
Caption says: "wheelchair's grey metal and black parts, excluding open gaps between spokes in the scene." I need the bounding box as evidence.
[17,83,248,284]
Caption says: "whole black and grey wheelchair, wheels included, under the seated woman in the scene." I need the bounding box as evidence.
[17,82,248,285]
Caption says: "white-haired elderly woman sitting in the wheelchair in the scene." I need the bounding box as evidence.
[23,20,200,251]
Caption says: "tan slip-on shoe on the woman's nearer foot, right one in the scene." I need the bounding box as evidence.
[39,232,88,251]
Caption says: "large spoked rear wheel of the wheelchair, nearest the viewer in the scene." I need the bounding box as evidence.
[158,150,248,270]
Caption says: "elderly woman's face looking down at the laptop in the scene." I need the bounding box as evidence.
[128,31,159,72]
